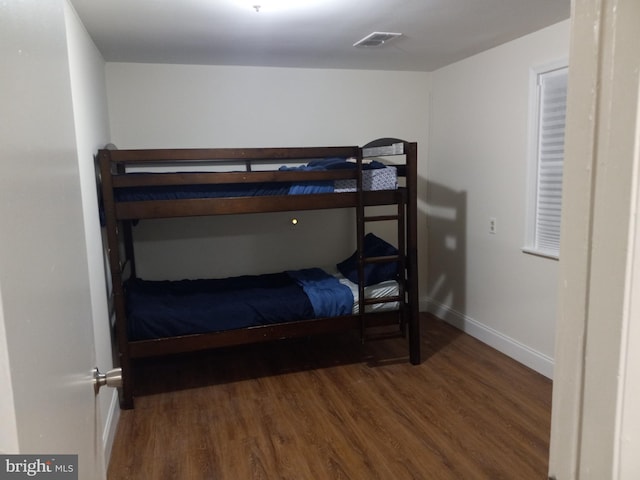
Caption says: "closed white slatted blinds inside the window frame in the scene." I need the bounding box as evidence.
[532,67,568,257]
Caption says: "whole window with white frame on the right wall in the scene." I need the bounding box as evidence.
[524,64,568,258]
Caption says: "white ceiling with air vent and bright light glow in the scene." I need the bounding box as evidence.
[70,0,570,71]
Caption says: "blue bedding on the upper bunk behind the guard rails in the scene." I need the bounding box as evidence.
[115,158,385,202]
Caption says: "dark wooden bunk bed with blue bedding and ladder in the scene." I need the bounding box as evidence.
[96,139,420,408]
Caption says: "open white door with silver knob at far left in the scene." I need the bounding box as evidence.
[0,0,105,480]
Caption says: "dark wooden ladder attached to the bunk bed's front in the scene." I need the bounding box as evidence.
[356,152,407,343]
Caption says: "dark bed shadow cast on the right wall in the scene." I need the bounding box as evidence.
[425,180,467,323]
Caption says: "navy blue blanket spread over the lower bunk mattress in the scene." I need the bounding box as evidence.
[125,268,353,340]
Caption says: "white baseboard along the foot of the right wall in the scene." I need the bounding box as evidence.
[420,299,553,379]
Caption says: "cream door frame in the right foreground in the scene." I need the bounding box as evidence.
[549,0,640,480]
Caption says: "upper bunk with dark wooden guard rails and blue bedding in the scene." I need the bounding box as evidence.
[97,139,417,221]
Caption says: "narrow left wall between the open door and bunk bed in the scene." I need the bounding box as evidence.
[65,3,119,461]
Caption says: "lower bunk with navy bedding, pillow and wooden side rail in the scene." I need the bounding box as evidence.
[114,234,419,408]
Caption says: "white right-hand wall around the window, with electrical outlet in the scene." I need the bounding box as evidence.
[427,20,569,376]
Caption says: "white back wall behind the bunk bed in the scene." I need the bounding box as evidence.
[106,63,430,284]
